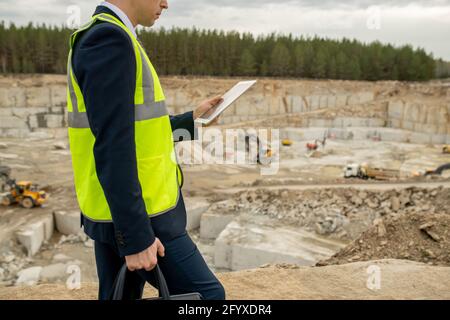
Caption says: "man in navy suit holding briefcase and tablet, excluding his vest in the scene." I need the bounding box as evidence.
[71,0,225,299]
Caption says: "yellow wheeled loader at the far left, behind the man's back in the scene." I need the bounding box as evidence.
[1,179,48,209]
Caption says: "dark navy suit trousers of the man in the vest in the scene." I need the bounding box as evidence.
[95,232,225,300]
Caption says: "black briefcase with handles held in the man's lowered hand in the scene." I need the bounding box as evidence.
[111,263,203,300]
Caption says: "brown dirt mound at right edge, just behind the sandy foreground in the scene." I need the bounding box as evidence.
[318,213,450,266]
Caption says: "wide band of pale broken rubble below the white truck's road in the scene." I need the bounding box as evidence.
[221,187,450,240]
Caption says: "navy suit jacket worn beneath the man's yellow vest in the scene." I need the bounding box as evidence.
[72,6,195,256]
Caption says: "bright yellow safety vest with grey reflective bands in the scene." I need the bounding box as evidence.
[67,13,182,222]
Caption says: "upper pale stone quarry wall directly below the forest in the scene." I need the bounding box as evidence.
[0,75,450,142]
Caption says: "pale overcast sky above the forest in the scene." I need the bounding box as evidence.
[0,0,450,61]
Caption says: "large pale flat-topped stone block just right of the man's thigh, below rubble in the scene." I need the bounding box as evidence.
[214,221,344,270]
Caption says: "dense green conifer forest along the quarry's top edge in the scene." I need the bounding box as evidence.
[0,22,450,81]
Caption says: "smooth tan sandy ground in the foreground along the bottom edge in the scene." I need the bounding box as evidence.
[0,260,450,300]
